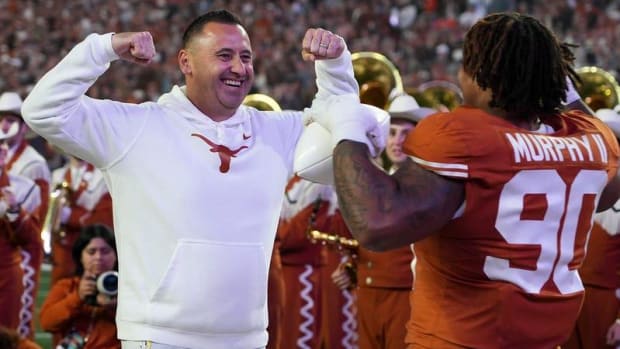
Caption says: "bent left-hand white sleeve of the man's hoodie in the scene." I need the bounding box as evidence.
[22,33,148,168]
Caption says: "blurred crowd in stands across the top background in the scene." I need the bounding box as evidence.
[0,0,620,109]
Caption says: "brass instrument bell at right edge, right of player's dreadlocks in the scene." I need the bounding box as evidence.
[575,67,620,111]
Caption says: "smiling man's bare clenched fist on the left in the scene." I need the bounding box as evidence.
[112,32,156,65]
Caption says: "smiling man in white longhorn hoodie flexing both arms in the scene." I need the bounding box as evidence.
[23,11,372,349]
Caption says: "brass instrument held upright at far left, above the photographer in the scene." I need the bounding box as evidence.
[41,181,70,253]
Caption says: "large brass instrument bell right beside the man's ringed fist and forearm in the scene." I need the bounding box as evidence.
[351,52,404,109]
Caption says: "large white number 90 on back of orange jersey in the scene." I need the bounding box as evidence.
[484,170,607,294]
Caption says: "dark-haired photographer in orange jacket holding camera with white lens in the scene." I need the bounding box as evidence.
[40,224,121,349]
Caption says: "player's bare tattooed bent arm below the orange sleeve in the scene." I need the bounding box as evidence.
[334,141,465,251]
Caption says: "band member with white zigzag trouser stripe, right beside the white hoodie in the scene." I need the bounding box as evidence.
[277,176,335,349]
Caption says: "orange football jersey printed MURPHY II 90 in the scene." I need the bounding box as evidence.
[404,107,620,349]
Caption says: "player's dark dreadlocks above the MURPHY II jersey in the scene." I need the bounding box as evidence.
[463,13,579,118]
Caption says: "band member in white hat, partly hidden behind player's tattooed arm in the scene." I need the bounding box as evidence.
[332,94,434,349]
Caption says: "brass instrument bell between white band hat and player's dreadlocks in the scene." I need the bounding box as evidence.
[406,80,463,111]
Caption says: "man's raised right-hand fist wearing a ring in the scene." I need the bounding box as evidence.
[301,28,347,61]
